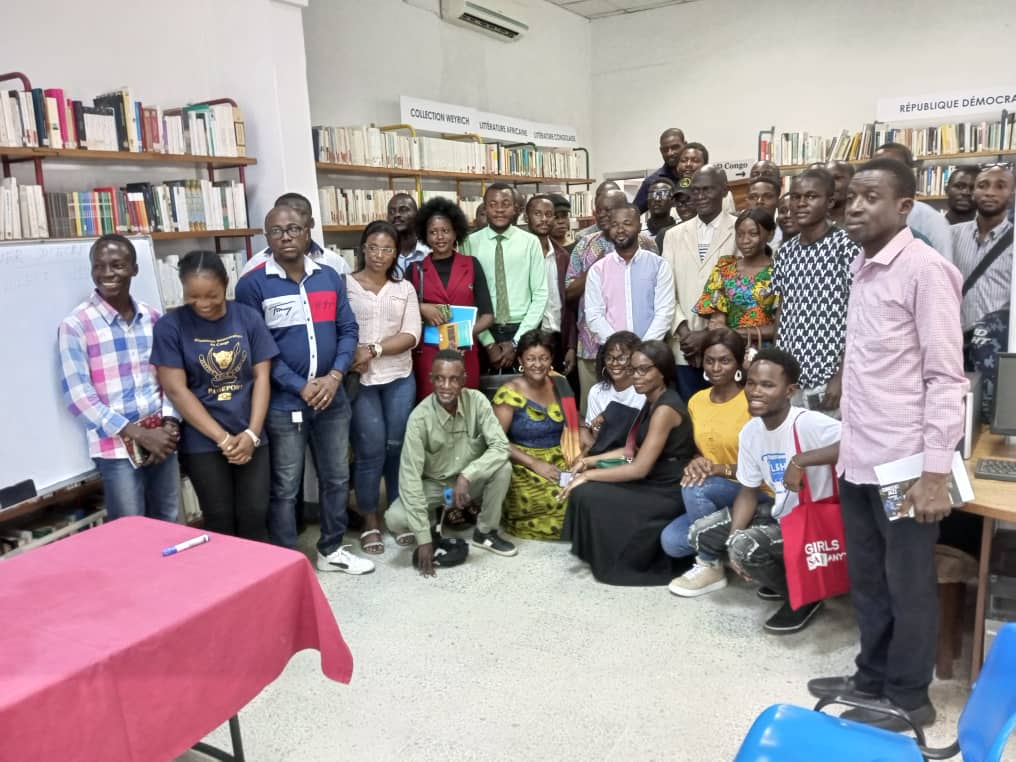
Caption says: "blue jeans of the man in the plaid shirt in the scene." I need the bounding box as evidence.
[93,452,180,522]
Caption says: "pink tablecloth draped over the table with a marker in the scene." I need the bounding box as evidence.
[0,518,353,762]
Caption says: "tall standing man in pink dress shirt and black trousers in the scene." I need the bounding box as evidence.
[808,158,967,729]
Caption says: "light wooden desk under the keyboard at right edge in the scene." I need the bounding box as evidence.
[963,428,1016,683]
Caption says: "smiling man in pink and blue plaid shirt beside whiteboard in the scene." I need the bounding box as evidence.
[58,235,180,521]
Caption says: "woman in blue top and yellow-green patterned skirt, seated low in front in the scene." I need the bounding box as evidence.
[494,330,578,539]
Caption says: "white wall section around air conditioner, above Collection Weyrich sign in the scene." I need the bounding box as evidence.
[304,0,595,172]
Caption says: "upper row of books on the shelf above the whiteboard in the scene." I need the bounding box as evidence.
[0,87,247,156]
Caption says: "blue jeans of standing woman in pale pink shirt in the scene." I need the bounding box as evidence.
[351,373,417,513]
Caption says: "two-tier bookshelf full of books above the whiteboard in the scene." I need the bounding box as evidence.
[0,72,260,258]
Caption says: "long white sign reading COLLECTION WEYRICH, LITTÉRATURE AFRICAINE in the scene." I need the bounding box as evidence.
[399,96,578,148]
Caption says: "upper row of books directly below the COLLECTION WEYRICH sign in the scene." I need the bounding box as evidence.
[311,126,585,179]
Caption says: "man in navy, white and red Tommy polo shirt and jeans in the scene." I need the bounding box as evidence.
[237,206,374,574]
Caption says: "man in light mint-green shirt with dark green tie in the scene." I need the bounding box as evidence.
[462,183,548,370]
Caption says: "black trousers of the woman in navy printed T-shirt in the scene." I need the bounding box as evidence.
[180,445,271,543]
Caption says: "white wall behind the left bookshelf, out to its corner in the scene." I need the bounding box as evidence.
[0,0,317,248]
